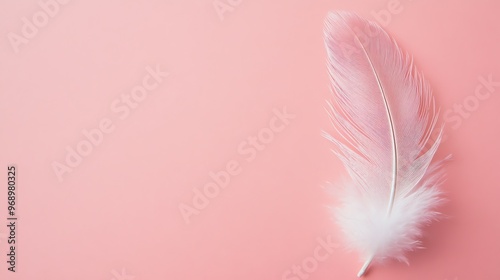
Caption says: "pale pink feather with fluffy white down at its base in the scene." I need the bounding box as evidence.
[325,12,450,276]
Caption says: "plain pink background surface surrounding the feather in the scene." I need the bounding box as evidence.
[0,0,500,280]
